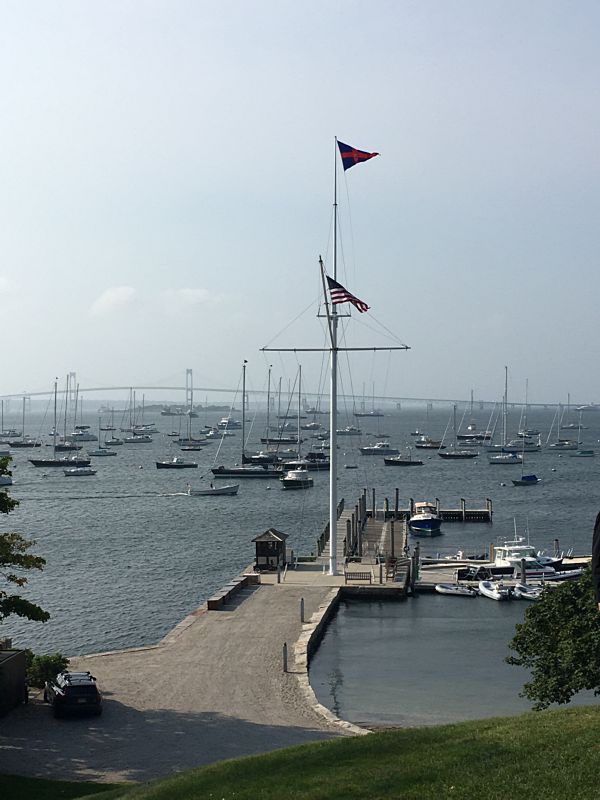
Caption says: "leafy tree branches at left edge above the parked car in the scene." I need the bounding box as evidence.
[0,458,50,623]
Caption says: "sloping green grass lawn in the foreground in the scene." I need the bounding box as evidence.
[0,706,600,800]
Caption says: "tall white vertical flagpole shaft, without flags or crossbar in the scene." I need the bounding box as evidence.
[329,136,338,575]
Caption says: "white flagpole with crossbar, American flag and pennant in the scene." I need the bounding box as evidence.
[262,138,409,575]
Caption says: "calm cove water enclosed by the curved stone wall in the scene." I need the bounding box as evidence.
[310,594,600,727]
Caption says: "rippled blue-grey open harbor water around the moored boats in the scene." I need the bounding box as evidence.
[0,406,600,655]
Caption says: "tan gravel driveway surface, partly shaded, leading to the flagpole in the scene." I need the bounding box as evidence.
[0,575,356,781]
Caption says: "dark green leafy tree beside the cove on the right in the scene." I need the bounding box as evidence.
[506,569,600,710]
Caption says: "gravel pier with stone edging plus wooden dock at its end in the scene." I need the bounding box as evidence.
[0,493,584,782]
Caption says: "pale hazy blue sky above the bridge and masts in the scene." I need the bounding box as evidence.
[0,0,600,403]
